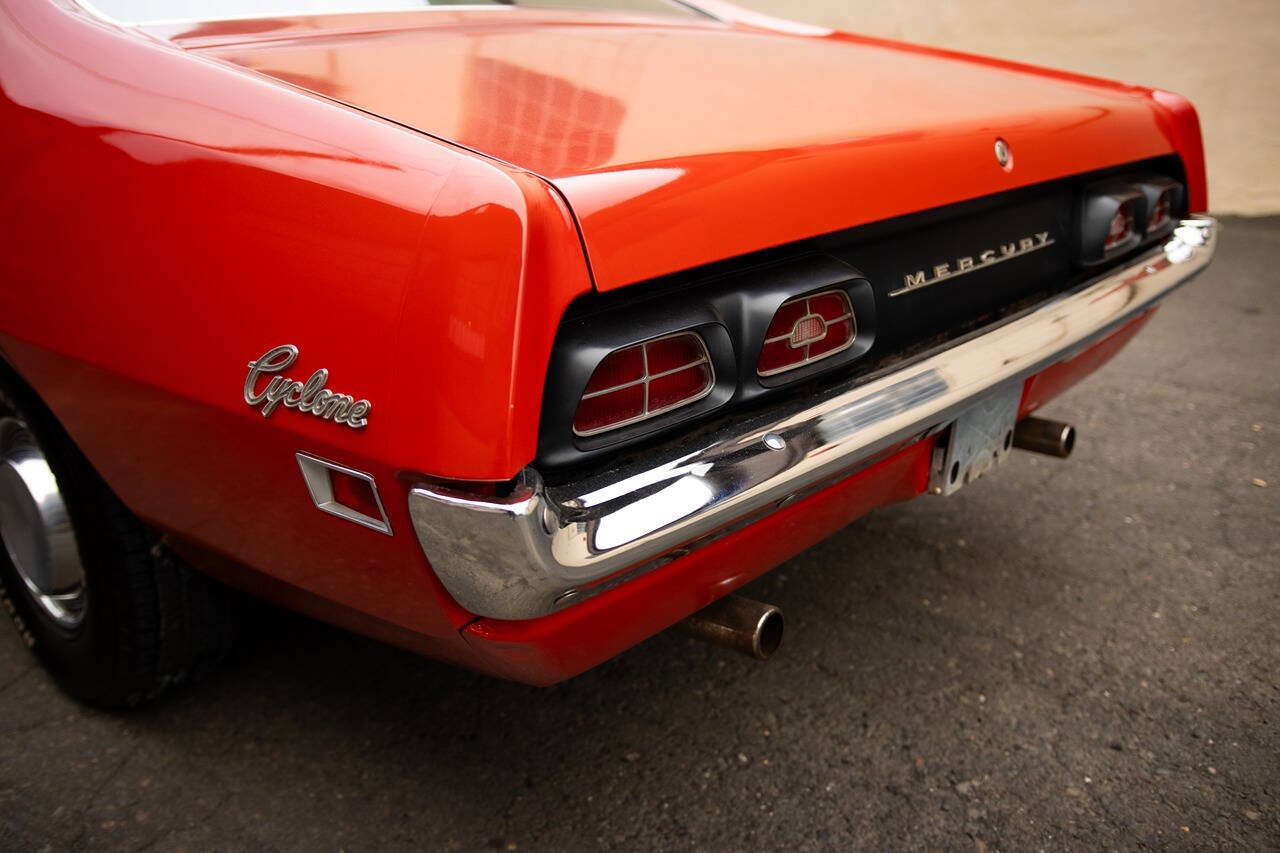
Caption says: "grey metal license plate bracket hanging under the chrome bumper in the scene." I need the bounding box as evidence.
[929,384,1023,494]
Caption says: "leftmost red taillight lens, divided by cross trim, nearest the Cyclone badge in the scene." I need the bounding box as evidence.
[573,332,716,435]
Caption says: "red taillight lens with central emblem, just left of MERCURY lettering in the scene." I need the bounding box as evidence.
[755,291,858,377]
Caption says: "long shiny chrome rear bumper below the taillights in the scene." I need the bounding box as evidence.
[408,216,1217,619]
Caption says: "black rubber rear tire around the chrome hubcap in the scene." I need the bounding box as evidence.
[0,369,241,708]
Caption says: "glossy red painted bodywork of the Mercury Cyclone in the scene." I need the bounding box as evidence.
[0,0,1204,683]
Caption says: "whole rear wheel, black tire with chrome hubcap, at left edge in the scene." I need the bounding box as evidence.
[0,382,238,707]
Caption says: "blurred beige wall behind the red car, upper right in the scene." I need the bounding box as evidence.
[737,0,1280,214]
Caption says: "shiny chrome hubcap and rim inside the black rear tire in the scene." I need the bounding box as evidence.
[0,418,87,628]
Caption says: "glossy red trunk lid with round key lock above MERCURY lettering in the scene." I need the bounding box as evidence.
[180,10,1194,289]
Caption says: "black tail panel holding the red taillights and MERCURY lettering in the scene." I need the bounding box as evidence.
[535,156,1187,479]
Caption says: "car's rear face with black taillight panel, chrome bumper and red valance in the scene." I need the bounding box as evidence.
[410,157,1216,683]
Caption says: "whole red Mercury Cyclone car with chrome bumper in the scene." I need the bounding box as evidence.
[0,0,1216,706]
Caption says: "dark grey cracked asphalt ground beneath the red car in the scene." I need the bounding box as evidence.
[0,218,1280,850]
